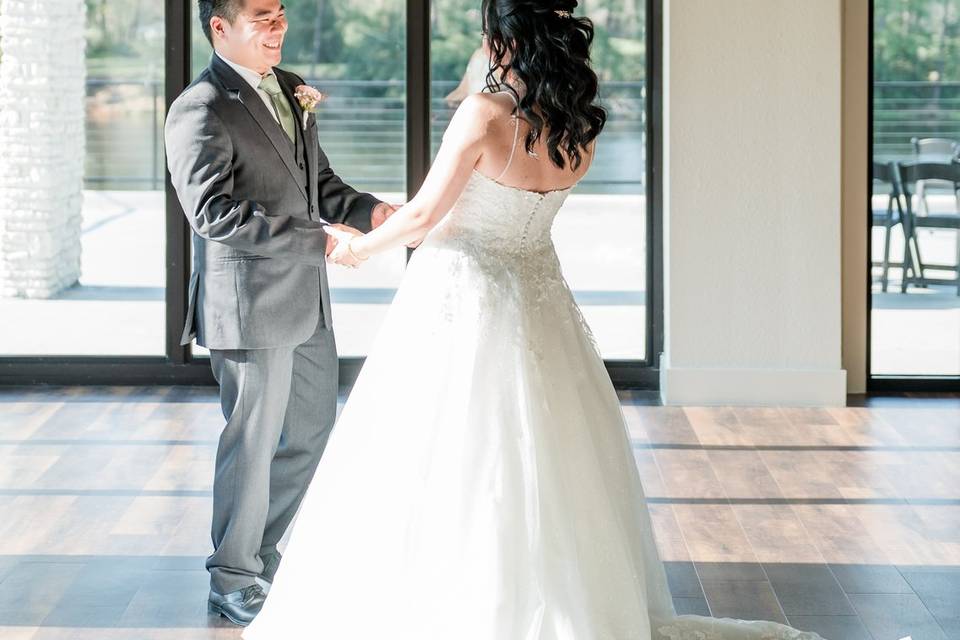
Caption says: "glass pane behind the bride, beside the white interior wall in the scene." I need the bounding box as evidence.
[430,0,648,360]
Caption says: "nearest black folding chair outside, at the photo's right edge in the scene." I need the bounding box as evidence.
[899,162,960,296]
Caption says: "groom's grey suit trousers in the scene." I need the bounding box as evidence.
[207,319,338,594]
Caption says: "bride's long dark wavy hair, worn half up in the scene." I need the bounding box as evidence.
[481,0,607,171]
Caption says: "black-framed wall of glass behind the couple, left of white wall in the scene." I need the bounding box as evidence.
[0,0,659,383]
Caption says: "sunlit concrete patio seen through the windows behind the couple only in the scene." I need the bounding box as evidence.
[0,190,646,359]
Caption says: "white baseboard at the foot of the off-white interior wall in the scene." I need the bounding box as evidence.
[660,367,847,407]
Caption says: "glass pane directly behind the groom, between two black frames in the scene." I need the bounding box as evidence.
[193,0,406,356]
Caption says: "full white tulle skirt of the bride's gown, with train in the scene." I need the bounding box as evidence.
[243,244,817,640]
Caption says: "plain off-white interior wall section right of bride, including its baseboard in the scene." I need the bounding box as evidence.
[661,0,845,404]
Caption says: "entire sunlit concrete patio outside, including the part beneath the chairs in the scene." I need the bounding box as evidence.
[0,190,960,375]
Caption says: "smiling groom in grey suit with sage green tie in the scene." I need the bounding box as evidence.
[165,0,394,625]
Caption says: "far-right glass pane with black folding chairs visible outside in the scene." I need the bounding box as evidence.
[870,0,960,376]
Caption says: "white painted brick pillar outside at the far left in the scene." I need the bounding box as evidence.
[0,0,86,298]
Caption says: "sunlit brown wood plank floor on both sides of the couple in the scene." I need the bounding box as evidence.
[0,387,960,640]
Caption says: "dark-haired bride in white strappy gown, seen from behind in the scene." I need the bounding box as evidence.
[243,0,819,640]
